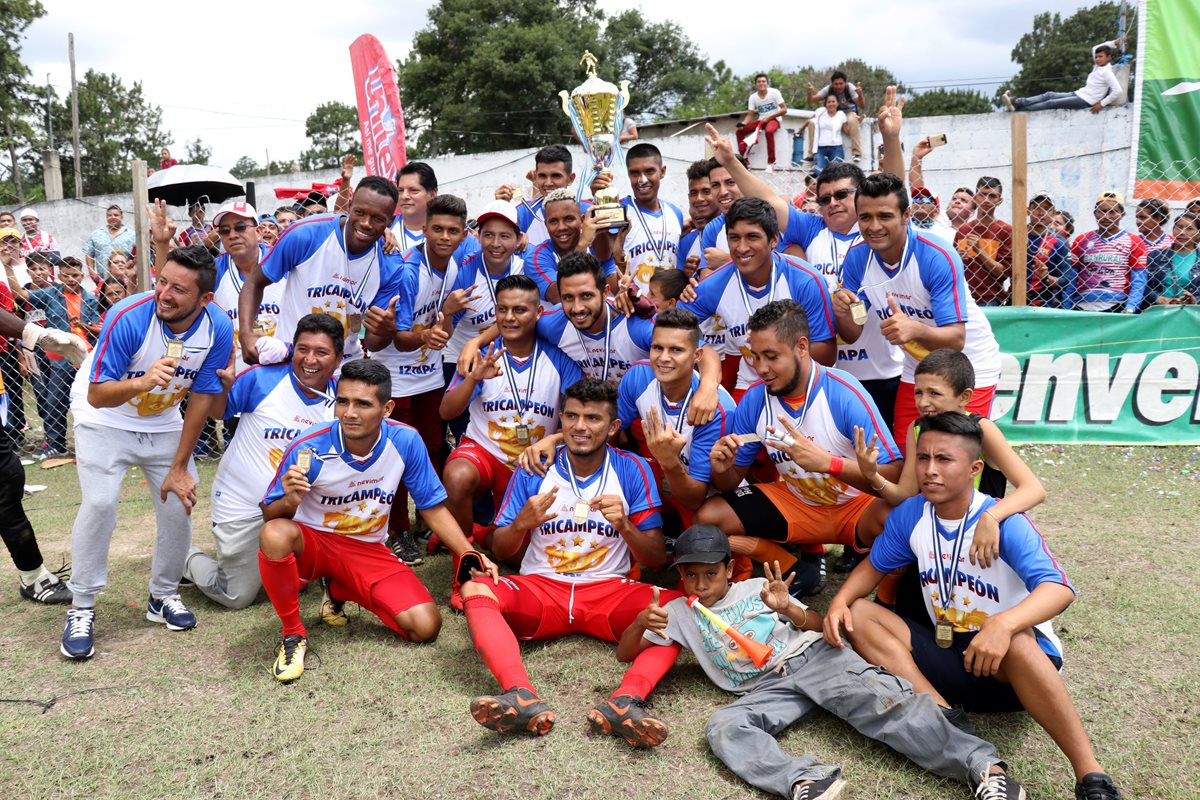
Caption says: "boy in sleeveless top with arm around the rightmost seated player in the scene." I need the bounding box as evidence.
[854,348,1046,616]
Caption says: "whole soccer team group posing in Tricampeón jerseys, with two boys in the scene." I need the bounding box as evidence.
[21,95,1120,800]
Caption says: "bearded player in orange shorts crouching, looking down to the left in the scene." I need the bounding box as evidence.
[696,300,902,596]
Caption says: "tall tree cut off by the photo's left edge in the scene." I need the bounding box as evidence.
[0,0,46,203]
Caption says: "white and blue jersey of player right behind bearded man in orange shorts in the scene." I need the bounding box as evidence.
[678,250,834,389]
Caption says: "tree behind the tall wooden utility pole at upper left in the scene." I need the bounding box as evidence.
[53,70,170,197]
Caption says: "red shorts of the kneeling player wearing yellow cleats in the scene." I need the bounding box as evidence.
[296,523,433,625]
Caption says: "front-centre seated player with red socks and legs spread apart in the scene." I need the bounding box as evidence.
[460,377,679,747]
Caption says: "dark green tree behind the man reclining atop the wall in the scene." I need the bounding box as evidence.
[993,2,1138,102]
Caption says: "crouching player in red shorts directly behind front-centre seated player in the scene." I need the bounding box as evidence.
[440,275,583,551]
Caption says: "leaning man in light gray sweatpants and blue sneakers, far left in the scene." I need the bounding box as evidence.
[59,246,233,658]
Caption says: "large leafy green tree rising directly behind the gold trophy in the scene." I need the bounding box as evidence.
[396,0,713,155]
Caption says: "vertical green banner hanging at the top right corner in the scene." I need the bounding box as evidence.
[1133,0,1200,200]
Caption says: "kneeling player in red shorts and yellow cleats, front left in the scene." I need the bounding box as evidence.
[258,360,497,682]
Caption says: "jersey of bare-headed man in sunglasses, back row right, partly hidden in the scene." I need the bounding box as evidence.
[784,206,904,380]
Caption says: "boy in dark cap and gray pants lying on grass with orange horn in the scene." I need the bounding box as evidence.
[617,525,1025,800]
